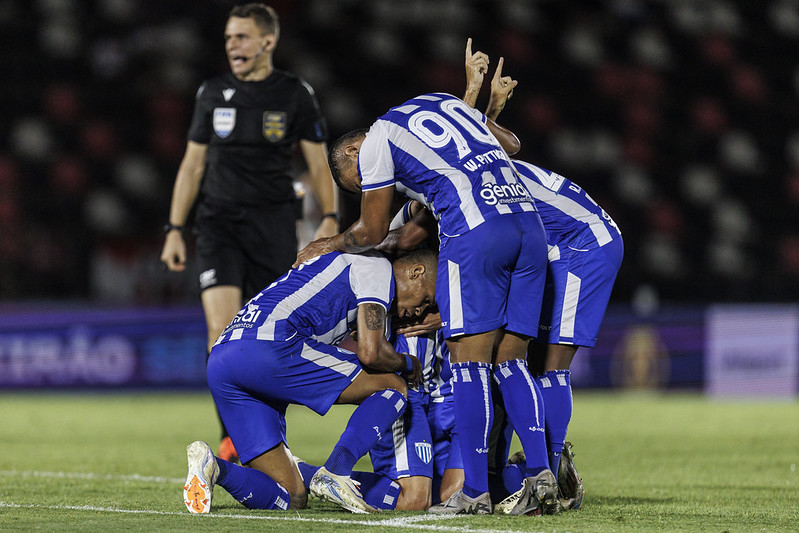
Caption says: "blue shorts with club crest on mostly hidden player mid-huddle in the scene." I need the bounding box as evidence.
[369,389,433,479]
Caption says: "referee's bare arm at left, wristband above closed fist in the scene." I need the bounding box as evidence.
[161,141,208,272]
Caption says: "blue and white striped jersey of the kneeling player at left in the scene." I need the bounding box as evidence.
[216,252,394,345]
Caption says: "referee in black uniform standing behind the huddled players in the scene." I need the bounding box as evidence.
[161,3,338,460]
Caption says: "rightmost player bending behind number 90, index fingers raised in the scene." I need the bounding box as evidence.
[464,42,624,510]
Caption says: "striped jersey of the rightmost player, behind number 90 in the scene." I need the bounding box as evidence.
[513,159,621,252]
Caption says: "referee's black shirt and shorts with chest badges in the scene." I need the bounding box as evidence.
[188,70,327,301]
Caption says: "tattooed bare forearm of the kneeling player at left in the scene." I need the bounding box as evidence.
[358,303,421,384]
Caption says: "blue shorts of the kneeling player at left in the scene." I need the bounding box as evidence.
[207,337,361,464]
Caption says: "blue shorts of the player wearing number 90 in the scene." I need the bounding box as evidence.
[436,212,547,338]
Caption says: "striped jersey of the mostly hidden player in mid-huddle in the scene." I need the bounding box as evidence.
[394,329,452,401]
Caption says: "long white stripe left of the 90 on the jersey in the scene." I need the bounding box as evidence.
[382,120,485,229]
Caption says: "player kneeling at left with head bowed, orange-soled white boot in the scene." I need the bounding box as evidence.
[183,248,435,513]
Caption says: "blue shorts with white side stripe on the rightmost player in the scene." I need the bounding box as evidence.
[536,237,624,347]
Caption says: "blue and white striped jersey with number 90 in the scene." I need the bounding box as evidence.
[358,93,535,237]
